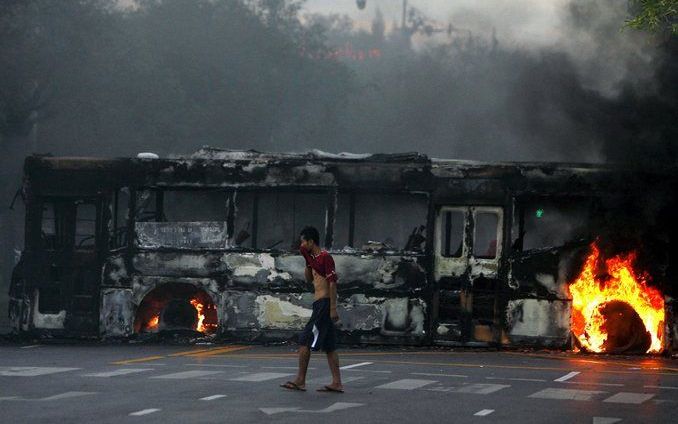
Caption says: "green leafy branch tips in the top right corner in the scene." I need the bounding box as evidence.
[626,0,678,35]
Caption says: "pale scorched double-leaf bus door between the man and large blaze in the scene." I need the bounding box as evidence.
[432,205,504,343]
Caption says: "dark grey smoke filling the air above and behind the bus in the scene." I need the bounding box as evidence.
[0,0,678,325]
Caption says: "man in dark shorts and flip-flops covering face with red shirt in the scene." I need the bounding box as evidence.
[281,227,344,393]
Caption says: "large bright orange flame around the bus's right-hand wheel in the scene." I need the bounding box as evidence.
[569,244,665,353]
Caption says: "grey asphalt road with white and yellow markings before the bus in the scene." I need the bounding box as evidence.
[0,344,678,424]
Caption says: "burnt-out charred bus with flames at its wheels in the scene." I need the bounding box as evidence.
[10,149,678,353]
